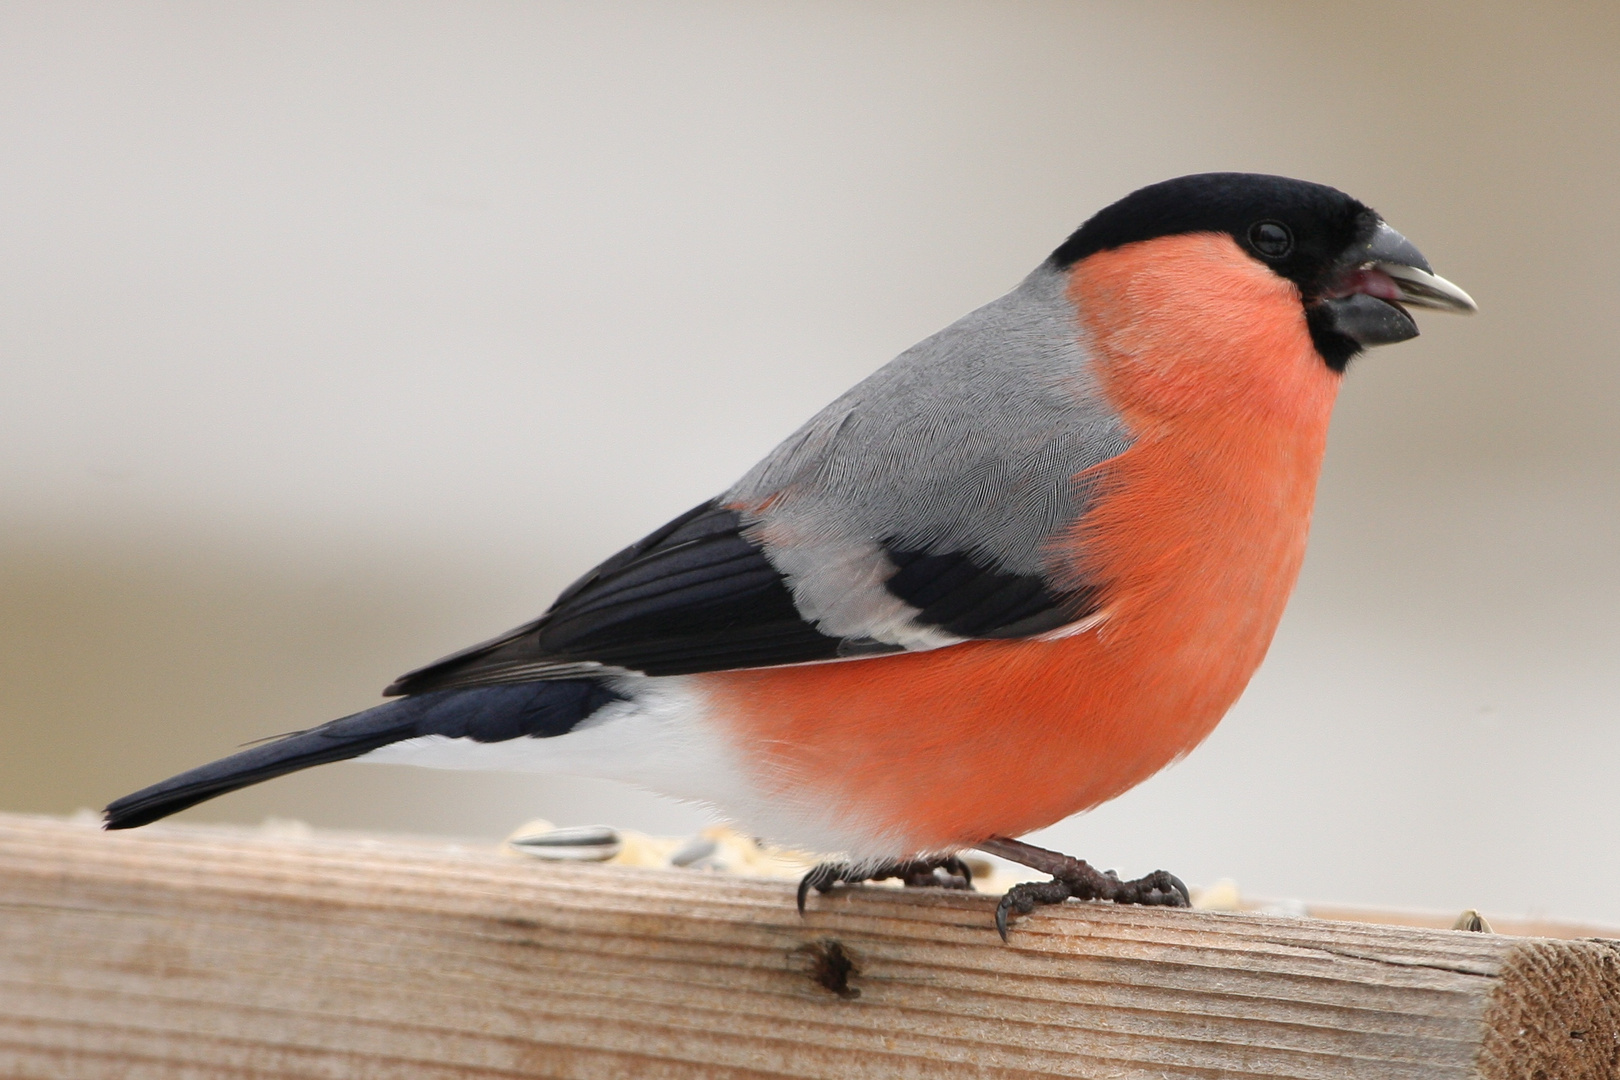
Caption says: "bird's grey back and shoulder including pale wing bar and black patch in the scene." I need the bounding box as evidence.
[721,267,1131,649]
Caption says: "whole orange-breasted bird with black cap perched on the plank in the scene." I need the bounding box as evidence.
[105,173,1474,938]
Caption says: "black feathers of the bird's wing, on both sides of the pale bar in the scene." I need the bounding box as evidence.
[384,502,1090,695]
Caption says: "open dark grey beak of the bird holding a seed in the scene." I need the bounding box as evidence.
[1317,222,1479,345]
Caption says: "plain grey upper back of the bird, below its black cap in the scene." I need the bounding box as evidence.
[723,266,1131,576]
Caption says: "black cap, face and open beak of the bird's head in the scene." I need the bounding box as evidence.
[1050,173,1476,371]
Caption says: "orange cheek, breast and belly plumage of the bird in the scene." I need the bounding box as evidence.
[701,235,1338,853]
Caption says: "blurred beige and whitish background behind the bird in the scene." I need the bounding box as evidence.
[0,0,1620,923]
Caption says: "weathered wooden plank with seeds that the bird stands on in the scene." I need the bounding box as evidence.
[0,816,1620,1080]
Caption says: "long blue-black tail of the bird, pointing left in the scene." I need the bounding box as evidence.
[105,678,624,829]
